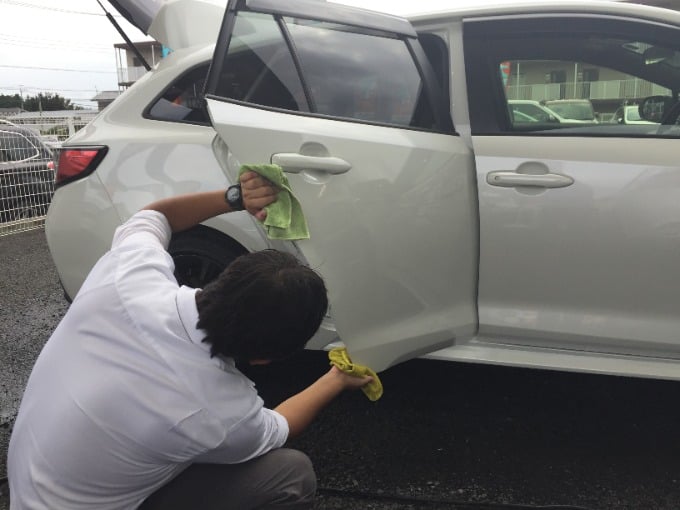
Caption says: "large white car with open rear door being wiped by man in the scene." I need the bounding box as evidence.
[46,0,680,379]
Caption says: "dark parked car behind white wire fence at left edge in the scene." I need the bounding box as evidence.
[0,122,54,223]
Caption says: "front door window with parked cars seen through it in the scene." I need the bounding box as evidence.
[466,19,680,137]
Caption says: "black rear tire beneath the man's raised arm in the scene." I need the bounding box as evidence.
[168,225,246,288]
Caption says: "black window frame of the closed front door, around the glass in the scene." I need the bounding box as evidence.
[463,13,680,139]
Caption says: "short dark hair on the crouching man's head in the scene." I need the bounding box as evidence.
[196,250,328,361]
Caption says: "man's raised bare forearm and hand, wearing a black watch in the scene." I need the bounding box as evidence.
[144,172,277,232]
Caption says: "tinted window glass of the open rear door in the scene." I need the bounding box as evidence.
[211,12,434,129]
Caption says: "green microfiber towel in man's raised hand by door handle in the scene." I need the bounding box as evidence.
[239,165,309,241]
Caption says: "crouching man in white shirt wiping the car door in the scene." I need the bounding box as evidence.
[8,172,371,510]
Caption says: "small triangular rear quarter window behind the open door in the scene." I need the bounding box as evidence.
[145,63,210,125]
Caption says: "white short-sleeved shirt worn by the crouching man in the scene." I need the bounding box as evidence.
[8,211,288,510]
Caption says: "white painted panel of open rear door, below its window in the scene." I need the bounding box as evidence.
[208,99,477,370]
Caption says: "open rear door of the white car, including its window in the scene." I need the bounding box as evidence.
[206,0,478,370]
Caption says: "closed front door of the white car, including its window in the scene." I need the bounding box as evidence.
[464,10,680,359]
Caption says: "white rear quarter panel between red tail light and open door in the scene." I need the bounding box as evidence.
[46,46,271,298]
